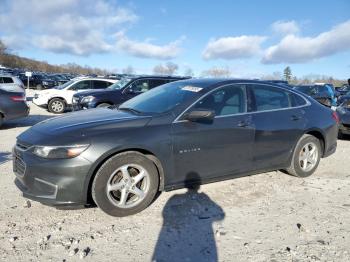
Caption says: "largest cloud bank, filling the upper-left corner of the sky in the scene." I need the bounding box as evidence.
[0,0,138,55]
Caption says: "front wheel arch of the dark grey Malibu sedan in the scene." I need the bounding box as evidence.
[85,147,165,204]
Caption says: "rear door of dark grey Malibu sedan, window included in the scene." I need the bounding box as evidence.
[248,84,307,170]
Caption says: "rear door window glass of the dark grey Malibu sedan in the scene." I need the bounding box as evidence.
[253,85,291,111]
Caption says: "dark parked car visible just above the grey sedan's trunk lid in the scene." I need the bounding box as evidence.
[294,85,336,107]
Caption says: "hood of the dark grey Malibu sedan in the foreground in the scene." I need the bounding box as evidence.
[18,108,152,145]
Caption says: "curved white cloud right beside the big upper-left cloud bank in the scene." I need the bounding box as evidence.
[116,32,185,60]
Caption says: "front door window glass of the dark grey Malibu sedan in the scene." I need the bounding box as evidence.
[192,85,246,116]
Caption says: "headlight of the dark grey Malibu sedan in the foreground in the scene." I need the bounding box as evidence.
[33,145,89,158]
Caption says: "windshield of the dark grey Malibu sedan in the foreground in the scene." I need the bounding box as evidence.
[119,81,203,113]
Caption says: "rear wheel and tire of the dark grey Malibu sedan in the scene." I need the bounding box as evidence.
[286,135,322,177]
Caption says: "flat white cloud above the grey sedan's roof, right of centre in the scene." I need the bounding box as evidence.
[202,35,266,60]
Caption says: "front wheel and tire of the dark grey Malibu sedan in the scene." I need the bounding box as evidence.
[91,152,159,217]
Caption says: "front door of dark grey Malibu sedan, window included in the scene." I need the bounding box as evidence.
[169,85,254,184]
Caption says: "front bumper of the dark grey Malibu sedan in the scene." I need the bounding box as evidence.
[13,146,91,207]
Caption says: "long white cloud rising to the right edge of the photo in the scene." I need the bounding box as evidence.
[262,20,350,64]
